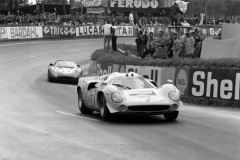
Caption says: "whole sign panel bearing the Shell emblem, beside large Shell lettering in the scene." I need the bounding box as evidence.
[174,67,189,97]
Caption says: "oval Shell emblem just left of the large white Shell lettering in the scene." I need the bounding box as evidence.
[176,69,188,95]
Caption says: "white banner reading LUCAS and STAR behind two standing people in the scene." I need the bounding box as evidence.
[76,26,134,37]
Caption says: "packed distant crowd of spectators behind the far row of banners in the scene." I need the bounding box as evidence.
[0,13,240,26]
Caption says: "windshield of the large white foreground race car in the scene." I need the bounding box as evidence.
[108,76,154,89]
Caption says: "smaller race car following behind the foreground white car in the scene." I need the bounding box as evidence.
[48,60,82,83]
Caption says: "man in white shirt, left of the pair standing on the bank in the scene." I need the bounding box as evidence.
[103,21,112,52]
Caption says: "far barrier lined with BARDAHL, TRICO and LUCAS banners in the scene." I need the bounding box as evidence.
[0,25,221,41]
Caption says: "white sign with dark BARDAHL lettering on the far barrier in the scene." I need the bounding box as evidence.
[7,26,43,39]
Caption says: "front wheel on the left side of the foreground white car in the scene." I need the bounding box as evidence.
[100,94,111,121]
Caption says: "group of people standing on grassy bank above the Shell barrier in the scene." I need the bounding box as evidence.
[135,26,204,59]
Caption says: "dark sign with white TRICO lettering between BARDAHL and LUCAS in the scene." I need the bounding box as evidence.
[42,26,76,37]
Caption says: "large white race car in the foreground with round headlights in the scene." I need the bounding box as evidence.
[77,72,183,121]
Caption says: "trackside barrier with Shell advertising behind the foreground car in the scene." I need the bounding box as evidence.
[89,61,240,104]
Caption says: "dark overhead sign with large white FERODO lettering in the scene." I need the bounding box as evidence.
[110,0,159,12]
